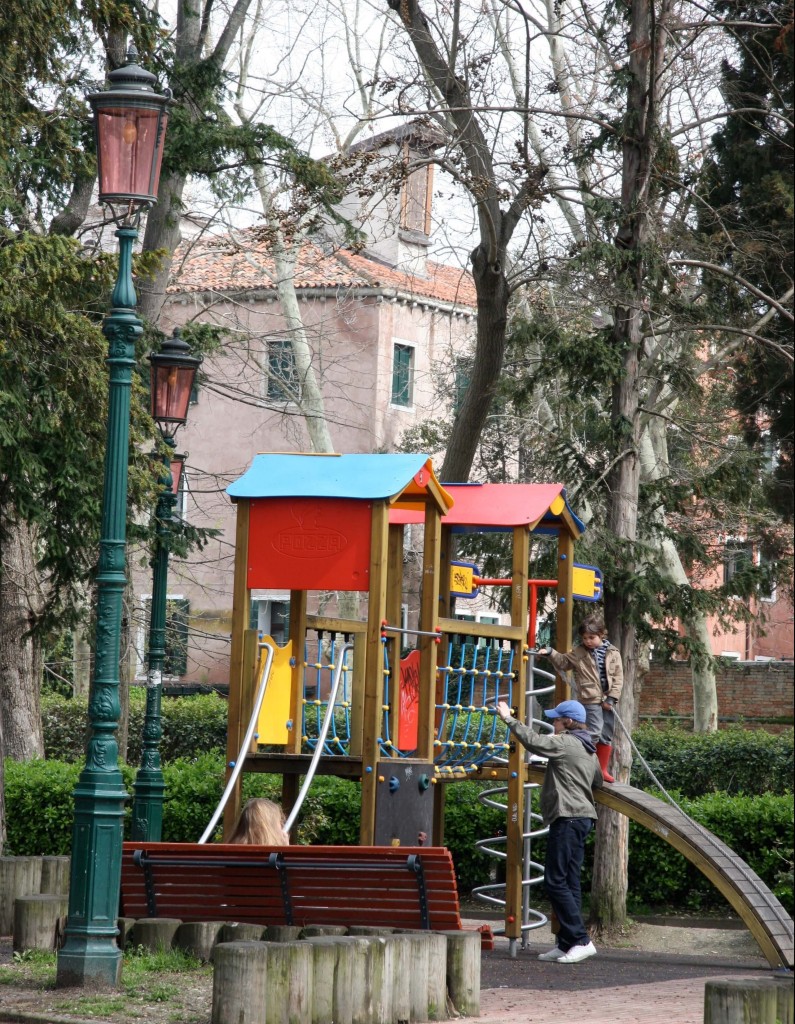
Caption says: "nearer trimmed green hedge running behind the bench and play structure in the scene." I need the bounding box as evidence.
[4,755,794,913]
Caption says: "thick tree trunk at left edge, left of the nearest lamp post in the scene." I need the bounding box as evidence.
[0,520,44,761]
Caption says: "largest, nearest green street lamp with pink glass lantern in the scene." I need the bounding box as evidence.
[56,46,169,986]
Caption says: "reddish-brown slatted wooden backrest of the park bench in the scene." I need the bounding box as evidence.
[121,843,462,931]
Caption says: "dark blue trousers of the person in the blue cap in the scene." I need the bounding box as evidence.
[544,818,593,952]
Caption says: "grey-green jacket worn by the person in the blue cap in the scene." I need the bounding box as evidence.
[506,718,602,825]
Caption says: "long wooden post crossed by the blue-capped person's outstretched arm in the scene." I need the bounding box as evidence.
[505,526,530,940]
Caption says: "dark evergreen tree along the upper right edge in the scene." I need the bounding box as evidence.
[702,0,795,521]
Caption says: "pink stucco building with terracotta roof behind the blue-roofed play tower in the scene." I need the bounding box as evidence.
[134,201,475,684]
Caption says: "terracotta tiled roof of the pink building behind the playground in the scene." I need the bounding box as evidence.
[168,230,476,308]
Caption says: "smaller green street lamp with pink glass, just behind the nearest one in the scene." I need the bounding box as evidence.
[131,328,202,843]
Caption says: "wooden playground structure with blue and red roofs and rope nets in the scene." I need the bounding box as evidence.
[223,455,793,965]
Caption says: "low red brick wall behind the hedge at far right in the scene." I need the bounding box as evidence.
[639,662,795,725]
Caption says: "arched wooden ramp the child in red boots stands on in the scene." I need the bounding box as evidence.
[528,764,793,968]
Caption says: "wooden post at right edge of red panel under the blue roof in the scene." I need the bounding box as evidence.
[360,502,389,846]
